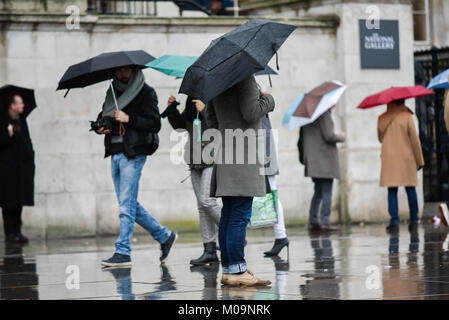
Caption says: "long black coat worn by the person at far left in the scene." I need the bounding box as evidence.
[0,113,35,207]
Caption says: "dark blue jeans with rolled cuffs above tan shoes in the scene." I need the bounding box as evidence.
[218,197,253,274]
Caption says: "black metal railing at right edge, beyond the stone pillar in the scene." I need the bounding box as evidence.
[415,48,449,201]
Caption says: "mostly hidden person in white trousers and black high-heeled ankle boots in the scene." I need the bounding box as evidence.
[262,114,289,257]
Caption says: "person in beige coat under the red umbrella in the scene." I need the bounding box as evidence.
[377,100,424,232]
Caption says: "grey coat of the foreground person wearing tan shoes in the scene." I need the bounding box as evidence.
[206,76,274,197]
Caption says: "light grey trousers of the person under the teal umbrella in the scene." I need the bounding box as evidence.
[191,167,221,243]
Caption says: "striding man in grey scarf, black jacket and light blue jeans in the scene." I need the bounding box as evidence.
[97,66,177,267]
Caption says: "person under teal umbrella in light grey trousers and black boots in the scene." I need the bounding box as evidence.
[163,96,221,266]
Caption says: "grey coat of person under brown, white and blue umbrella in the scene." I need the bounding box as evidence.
[302,110,345,179]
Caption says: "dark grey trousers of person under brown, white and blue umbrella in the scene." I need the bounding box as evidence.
[309,178,334,224]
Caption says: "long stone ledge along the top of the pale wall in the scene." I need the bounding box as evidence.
[0,12,340,29]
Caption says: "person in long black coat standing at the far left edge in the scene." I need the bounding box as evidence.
[0,94,35,243]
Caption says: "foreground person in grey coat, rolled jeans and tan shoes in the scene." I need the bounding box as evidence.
[202,76,275,286]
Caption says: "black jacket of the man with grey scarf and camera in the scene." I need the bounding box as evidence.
[97,84,161,159]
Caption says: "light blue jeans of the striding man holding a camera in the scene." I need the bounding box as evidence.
[111,153,171,255]
